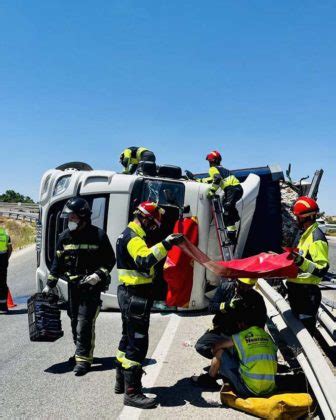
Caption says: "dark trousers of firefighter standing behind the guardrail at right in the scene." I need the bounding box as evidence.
[287,282,321,334]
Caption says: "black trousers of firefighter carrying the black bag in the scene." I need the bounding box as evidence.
[68,284,101,363]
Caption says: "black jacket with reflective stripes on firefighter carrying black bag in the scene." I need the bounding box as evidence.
[47,224,115,290]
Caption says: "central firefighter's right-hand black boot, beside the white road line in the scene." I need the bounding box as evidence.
[124,366,157,409]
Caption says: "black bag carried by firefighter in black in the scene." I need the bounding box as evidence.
[27,293,64,341]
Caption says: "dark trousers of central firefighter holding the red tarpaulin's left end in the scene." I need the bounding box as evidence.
[118,284,153,369]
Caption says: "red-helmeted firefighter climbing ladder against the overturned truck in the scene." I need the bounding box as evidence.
[185,150,243,245]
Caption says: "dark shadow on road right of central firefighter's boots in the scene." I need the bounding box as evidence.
[144,378,222,408]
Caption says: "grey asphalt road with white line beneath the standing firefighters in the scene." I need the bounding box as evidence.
[0,247,250,419]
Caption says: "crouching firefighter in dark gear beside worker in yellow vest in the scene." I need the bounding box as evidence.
[193,278,267,389]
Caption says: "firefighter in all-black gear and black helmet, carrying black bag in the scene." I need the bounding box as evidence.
[43,197,115,376]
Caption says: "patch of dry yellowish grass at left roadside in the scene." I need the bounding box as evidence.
[0,217,36,250]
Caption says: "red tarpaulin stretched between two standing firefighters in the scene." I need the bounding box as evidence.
[179,238,298,278]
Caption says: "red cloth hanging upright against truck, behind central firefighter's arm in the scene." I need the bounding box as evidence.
[163,217,198,308]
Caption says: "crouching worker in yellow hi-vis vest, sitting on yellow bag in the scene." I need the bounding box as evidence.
[210,303,277,398]
